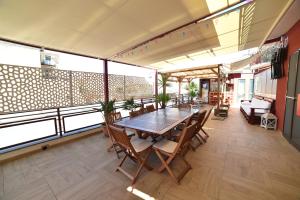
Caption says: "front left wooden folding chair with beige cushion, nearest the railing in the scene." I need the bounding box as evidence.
[109,125,152,185]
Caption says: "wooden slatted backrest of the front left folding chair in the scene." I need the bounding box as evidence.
[108,125,135,152]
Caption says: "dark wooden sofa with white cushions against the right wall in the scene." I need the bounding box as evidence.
[240,96,275,124]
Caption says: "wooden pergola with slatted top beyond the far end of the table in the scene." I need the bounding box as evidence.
[161,64,221,109]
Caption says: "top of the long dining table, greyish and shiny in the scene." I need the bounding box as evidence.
[115,108,198,135]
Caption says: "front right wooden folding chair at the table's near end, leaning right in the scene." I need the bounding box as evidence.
[153,124,196,183]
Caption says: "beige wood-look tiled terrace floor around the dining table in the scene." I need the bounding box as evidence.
[0,109,300,200]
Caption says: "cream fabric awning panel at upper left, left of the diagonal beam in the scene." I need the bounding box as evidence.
[0,0,219,58]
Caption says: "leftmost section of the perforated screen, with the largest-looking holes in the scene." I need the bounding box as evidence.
[0,65,70,113]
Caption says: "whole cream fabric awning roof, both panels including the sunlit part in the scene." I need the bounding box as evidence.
[0,0,296,71]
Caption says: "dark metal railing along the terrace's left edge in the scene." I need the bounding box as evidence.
[0,95,187,153]
